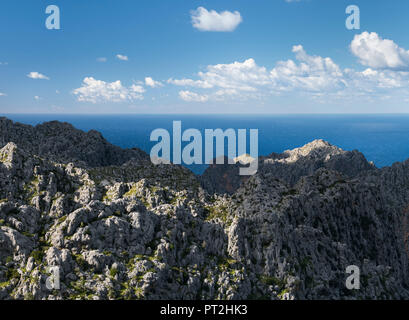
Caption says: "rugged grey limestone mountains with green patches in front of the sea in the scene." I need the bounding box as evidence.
[0,119,409,299]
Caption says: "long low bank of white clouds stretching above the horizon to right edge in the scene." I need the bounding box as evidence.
[168,40,409,102]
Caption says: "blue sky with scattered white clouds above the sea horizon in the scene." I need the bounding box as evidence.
[0,0,409,114]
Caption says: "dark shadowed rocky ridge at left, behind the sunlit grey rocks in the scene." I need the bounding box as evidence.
[0,117,149,167]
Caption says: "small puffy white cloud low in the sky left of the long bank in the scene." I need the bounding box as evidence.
[73,77,145,103]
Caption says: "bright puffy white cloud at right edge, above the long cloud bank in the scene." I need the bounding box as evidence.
[351,32,409,70]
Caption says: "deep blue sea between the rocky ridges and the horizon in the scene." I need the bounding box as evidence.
[3,114,409,173]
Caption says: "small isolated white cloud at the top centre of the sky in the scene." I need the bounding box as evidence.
[191,7,243,32]
